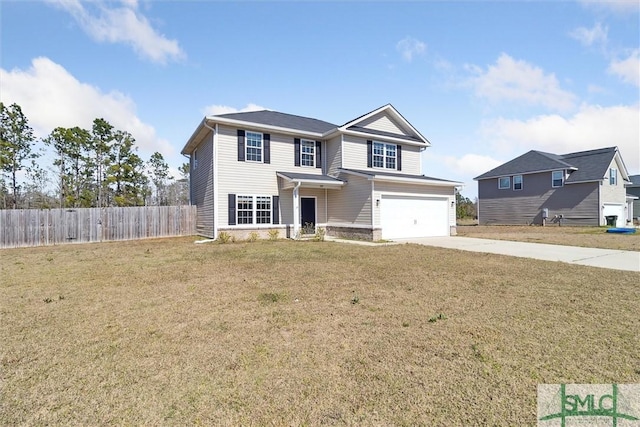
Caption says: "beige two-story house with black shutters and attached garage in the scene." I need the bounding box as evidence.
[182,105,462,240]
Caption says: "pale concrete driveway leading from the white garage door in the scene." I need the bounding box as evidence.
[395,236,640,272]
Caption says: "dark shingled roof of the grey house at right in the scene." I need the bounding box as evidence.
[474,147,627,184]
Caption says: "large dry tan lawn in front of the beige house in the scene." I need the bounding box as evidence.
[0,238,640,426]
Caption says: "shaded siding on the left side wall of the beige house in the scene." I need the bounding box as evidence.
[189,132,215,237]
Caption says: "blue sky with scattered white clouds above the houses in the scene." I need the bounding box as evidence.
[0,0,640,198]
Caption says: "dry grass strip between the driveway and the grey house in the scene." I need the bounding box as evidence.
[457,225,640,251]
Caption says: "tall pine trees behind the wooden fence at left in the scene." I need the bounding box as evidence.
[0,102,189,209]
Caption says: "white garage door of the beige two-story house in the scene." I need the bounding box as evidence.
[380,196,449,239]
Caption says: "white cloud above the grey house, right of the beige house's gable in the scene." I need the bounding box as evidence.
[466,53,576,111]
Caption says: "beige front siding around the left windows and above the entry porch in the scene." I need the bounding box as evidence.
[218,126,322,227]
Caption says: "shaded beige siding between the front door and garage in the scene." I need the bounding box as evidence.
[328,174,371,226]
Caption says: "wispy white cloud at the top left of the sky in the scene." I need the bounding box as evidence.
[48,0,185,64]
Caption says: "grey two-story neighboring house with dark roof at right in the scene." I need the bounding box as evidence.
[474,147,629,226]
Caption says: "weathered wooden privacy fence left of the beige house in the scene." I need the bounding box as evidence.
[0,206,196,248]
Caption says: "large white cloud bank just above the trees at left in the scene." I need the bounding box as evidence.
[0,57,175,159]
